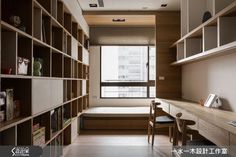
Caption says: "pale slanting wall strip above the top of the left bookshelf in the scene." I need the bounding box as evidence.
[62,0,89,36]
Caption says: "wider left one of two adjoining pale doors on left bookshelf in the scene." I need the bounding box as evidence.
[32,79,51,115]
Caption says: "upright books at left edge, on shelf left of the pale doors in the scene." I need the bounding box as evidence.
[0,89,20,122]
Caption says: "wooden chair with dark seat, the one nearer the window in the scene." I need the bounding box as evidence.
[148,101,175,146]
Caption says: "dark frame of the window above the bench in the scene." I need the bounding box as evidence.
[100,45,156,99]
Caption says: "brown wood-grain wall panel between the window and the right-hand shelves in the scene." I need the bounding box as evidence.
[156,12,181,98]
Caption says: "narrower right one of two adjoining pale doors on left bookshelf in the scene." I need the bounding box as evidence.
[51,80,63,106]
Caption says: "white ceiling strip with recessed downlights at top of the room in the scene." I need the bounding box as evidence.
[78,0,180,11]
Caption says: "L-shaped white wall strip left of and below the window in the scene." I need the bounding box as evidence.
[89,46,151,106]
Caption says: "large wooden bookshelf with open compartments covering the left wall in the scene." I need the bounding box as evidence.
[0,0,89,157]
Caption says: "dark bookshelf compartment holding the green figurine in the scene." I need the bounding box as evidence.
[33,43,51,77]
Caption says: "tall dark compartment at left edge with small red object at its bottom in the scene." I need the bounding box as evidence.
[1,29,17,75]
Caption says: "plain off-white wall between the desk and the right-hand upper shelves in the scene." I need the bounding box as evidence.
[182,53,236,112]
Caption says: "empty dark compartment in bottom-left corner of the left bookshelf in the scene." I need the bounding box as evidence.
[0,127,16,146]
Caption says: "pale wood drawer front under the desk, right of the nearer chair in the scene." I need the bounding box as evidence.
[199,119,229,146]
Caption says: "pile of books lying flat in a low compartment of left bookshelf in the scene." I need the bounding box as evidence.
[33,124,45,147]
